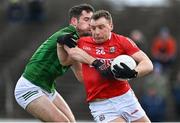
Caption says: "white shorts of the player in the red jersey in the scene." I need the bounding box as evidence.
[89,89,146,123]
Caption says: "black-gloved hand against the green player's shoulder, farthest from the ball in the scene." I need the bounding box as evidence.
[57,33,77,48]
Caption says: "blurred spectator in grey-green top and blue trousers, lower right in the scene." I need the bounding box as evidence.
[140,64,169,122]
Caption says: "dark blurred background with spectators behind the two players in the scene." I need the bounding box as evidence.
[0,0,180,122]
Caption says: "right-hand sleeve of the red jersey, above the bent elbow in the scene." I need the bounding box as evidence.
[122,37,140,55]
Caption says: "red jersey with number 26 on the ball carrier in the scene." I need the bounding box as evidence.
[78,33,139,102]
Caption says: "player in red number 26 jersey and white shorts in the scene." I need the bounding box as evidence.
[57,10,153,122]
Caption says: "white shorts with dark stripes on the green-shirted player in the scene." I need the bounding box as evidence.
[14,76,57,109]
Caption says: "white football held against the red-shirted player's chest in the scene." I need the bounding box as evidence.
[111,55,136,80]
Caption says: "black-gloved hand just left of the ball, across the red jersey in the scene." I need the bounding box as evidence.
[92,59,113,79]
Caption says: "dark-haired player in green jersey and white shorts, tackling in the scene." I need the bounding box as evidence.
[14,4,94,122]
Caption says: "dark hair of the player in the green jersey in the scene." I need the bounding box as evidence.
[69,4,94,19]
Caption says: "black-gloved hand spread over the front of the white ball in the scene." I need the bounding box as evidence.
[112,63,138,79]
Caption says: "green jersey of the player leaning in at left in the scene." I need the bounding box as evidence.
[23,25,78,92]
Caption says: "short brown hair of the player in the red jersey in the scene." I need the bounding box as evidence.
[91,10,112,22]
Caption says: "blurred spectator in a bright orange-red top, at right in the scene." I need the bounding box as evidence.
[151,27,176,68]
